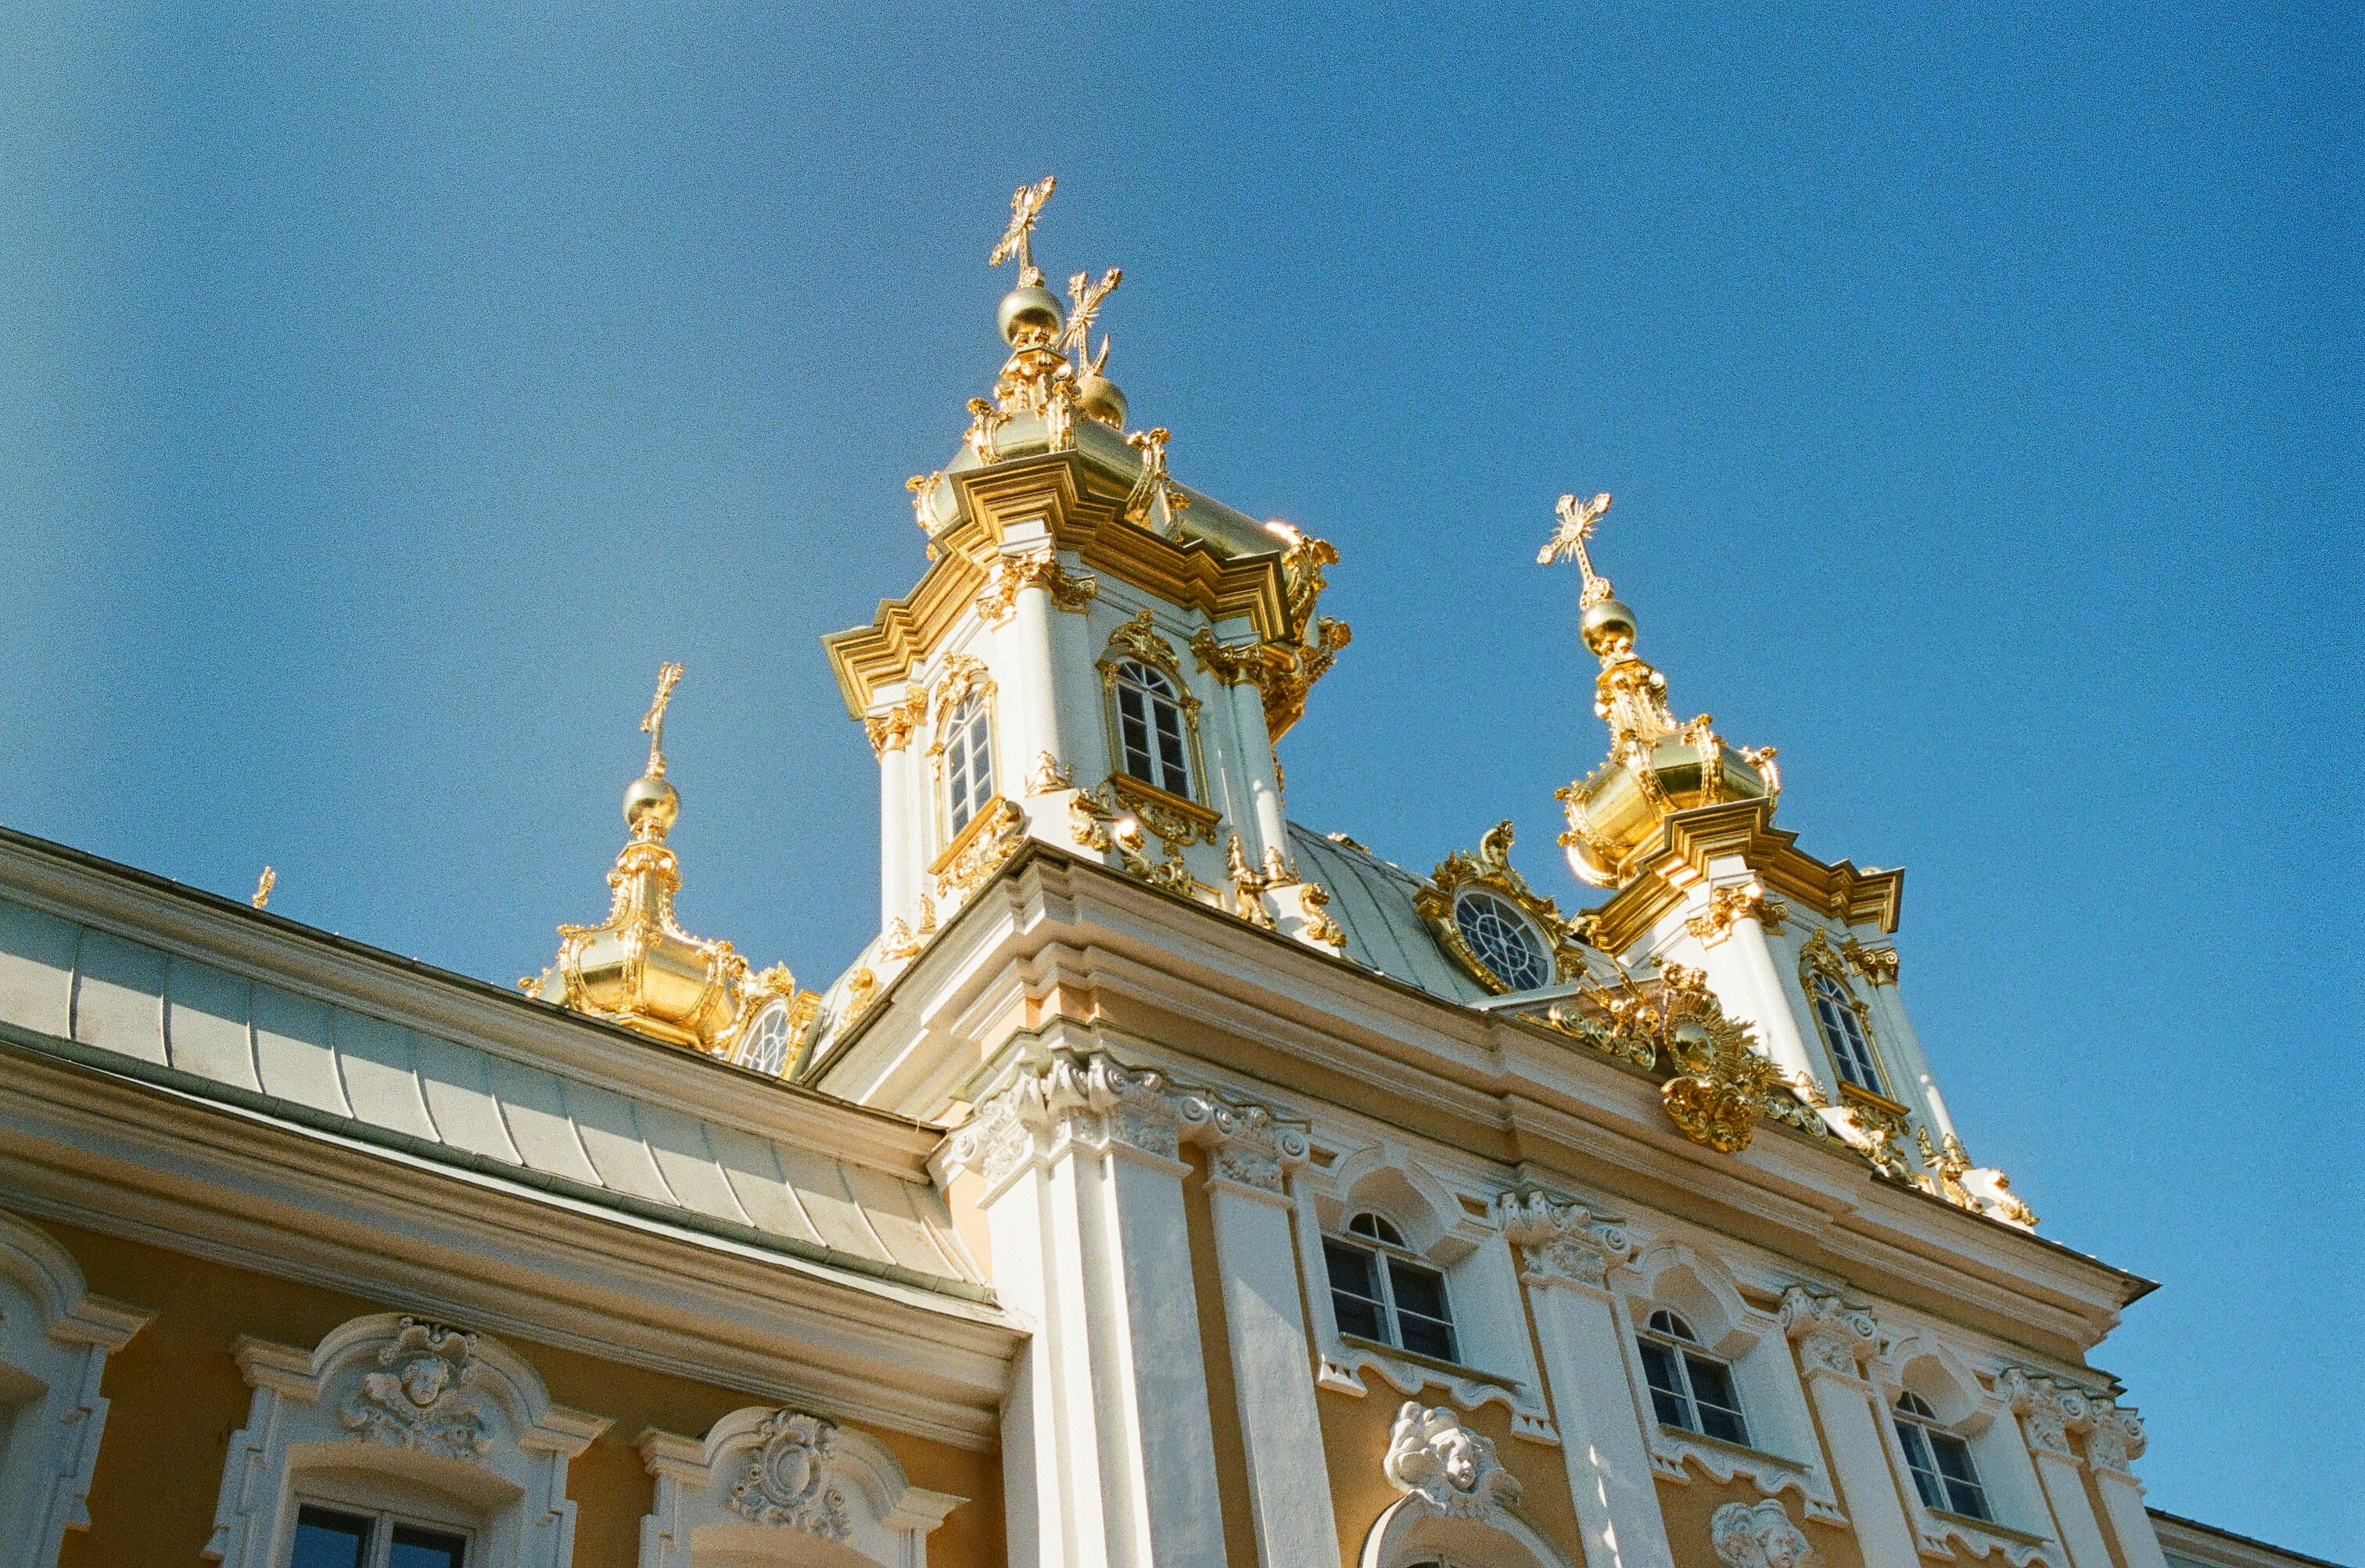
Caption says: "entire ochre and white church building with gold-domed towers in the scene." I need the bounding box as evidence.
[0,180,2308,1568]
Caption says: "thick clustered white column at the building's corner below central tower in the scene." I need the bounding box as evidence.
[942,1053,1222,1568]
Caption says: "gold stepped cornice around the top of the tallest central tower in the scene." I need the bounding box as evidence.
[820,452,1289,719]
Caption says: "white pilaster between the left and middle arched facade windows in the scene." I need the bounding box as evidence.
[1495,1192,1674,1568]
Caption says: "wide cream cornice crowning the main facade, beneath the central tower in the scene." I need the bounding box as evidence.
[820,847,2148,1362]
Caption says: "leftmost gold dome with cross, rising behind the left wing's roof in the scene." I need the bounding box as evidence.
[520,665,802,1057]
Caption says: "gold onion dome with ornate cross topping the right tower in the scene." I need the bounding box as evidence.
[1535,494,1781,887]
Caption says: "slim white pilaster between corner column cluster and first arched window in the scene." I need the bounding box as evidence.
[1206,1114,1339,1568]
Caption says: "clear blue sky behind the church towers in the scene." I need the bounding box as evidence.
[0,5,2365,1561]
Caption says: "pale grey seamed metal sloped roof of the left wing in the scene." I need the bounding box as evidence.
[0,835,986,1301]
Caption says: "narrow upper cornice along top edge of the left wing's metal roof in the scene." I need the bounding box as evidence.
[0,827,937,1182]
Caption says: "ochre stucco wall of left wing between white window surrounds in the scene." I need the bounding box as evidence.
[40,1220,1005,1568]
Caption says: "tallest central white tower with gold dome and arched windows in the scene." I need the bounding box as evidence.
[825,180,1348,993]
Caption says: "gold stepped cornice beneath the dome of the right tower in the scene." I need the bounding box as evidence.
[1589,799,1906,953]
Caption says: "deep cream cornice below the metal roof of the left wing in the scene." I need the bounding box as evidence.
[0,1053,1024,1448]
